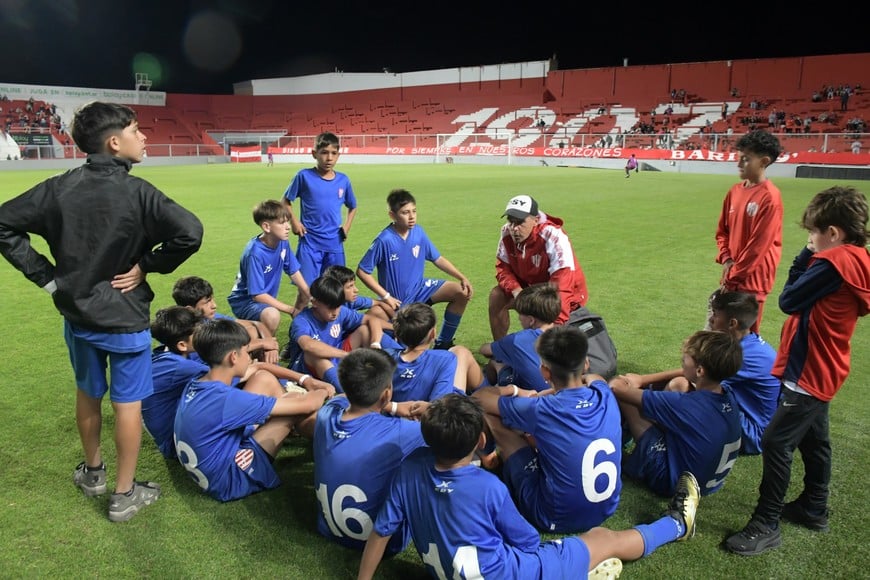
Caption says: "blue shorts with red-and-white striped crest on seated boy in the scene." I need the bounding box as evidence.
[208,428,281,501]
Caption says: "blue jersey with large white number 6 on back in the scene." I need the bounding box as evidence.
[498,381,622,533]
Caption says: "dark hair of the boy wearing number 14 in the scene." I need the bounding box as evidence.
[420,393,483,461]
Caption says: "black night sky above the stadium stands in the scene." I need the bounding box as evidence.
[0,0,870,94]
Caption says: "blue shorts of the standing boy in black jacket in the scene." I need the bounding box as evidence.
[63,321,154,403]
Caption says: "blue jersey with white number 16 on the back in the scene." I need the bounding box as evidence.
[313,397,425,554]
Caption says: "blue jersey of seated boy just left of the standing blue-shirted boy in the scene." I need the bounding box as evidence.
[227,236,299,316]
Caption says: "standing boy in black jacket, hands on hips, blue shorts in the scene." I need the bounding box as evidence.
[0,102,202,522]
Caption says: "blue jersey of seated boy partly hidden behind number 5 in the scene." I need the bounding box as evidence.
[722,332,780,455]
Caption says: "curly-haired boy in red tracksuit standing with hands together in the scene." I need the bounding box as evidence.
[707,130,782,334]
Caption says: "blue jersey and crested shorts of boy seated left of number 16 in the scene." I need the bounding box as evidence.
[174,380,281,501]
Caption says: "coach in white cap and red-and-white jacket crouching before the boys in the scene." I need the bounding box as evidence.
[489,195,589,340]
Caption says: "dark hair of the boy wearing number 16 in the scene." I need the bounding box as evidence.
[338,348,396,407]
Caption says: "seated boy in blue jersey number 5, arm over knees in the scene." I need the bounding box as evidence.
[610,330,743,496]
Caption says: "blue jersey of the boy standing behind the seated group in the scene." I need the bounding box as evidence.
[284,168,356,252]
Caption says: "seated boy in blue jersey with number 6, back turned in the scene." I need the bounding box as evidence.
[472,326,622,533]
